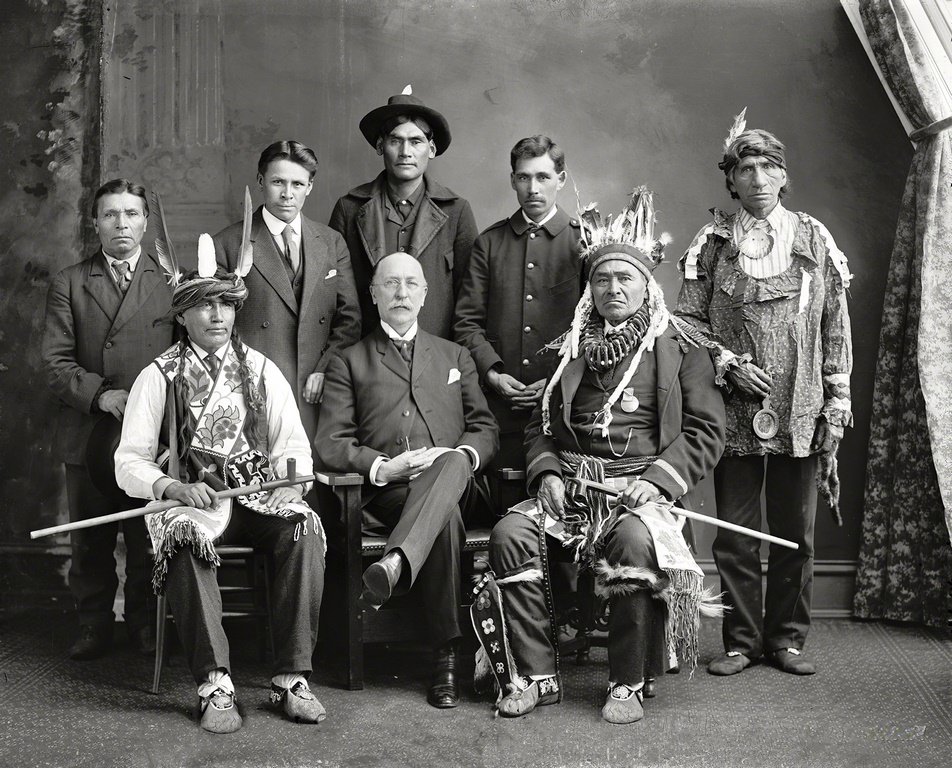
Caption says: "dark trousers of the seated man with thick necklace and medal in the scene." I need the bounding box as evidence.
[489,513,665,685]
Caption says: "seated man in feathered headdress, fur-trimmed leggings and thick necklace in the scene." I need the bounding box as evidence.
[473,189,724,723]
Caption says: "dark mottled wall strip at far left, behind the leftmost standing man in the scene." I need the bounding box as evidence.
[0,0,101,604]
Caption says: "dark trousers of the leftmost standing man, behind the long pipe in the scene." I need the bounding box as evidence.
[66,464,154,631]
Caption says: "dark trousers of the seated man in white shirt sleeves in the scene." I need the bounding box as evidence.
[165,503,324,683]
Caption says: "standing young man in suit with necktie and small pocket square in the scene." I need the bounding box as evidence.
[214,141,360,439]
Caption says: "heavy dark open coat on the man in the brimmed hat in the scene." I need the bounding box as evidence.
[330,172,477,339]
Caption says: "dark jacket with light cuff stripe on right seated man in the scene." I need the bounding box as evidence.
[526,327,726,508]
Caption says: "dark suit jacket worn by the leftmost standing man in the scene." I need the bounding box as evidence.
[42,255,172,464]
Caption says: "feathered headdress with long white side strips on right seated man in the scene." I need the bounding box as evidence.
[542,186,671,435]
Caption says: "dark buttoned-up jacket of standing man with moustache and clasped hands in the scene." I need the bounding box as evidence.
[453,209,583,432]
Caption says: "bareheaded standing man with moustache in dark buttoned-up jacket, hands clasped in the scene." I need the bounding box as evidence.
[453,136,582,470]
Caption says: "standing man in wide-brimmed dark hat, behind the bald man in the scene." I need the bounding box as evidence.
[330,85,477,339]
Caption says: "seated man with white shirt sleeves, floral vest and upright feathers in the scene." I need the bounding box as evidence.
[116,193,326,733]
